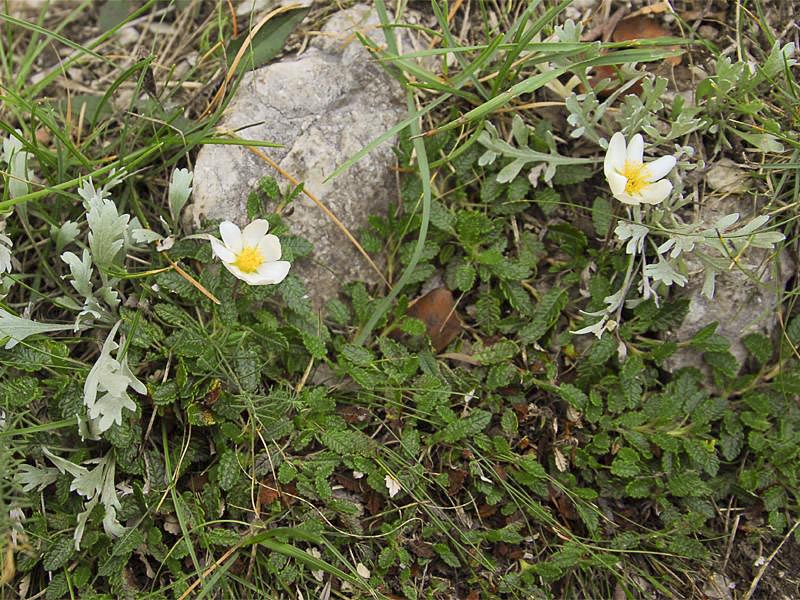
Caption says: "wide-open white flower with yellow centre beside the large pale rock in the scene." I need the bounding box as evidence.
[210,219,291,285]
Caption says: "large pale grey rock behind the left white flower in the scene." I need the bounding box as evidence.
[192,5,406,305]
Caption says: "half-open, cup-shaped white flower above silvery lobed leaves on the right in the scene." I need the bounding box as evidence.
[603,132,675,206]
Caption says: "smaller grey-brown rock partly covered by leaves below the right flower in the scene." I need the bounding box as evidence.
[665,194,795,371]
